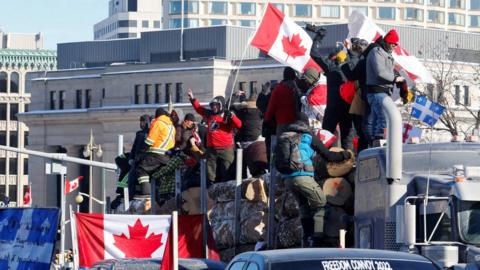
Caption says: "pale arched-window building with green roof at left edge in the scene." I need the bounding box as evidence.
[0,30,56,206]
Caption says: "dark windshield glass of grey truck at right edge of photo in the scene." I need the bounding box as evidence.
[458,201,480,245]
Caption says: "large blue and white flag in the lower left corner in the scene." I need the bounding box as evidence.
[0,208,59,270]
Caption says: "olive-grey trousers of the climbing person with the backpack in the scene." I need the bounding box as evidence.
[285,176,327,237]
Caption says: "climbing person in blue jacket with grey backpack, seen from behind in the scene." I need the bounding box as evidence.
[275,114,351,247]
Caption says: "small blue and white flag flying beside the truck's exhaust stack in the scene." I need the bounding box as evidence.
[412,96,445,127]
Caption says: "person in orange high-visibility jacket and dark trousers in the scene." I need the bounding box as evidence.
[137,108,175,199]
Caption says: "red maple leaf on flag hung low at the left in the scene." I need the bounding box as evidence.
[113,219,163,258]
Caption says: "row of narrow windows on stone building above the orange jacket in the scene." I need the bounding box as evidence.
[133,83,184,104]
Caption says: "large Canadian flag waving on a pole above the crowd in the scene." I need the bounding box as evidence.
[250,3,321,73]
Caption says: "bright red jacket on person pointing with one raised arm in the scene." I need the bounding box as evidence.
[188,99,242,148]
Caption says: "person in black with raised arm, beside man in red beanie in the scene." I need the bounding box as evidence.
[310,30,353,149]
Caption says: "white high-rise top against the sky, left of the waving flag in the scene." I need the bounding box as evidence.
[93,0,162,40]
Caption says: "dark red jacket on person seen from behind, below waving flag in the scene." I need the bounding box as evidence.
[264,82,296,124]
